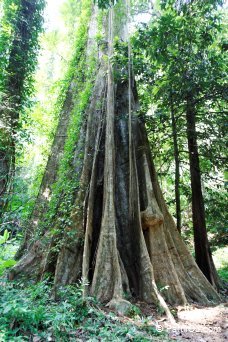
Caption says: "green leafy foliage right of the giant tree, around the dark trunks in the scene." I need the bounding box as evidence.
[132,0,227,243]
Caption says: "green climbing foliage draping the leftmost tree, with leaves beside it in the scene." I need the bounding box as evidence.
[0,0,44,223]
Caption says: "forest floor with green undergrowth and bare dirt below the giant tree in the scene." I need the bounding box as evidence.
[0,244,228,342]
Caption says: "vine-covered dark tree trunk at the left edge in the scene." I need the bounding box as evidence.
[0,0,44,217]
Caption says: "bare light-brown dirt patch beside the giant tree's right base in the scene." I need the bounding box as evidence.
[157,304,228,342]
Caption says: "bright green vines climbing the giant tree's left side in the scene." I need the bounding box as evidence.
[37,0,96,243]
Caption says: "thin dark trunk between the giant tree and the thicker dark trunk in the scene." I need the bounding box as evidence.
[170,91,181,232]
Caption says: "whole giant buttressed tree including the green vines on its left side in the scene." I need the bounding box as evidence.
[9,0,219,319]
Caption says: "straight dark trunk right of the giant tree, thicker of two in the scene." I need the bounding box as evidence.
[186,94,219,288]
